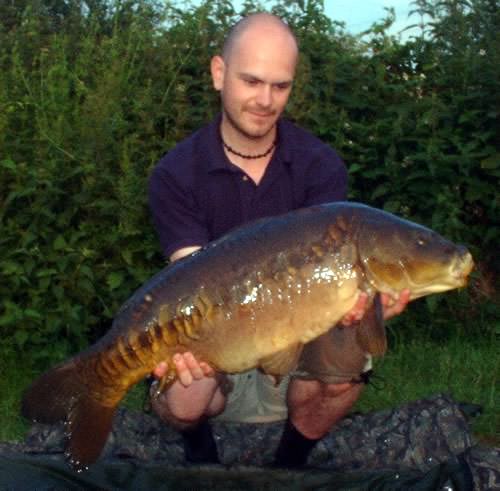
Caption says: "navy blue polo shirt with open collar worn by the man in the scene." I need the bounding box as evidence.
[149,115,347,258]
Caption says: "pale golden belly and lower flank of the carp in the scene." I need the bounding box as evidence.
[183,268,359,373]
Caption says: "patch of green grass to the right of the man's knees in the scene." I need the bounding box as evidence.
[357,336,500,446]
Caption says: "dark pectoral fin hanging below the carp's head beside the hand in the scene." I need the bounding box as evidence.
[354,293,387,356]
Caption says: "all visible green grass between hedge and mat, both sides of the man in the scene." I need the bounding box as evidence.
[0,334,500,446]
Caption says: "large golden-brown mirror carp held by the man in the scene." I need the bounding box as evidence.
[22,203,473,467]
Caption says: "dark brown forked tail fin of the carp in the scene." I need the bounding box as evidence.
[21,360,116,469]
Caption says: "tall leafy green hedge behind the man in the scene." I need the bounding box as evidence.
[0,0,500,360]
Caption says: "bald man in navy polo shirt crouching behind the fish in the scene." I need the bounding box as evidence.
[146,13,408,467]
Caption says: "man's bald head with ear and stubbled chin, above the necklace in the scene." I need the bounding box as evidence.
[210,13,298,143]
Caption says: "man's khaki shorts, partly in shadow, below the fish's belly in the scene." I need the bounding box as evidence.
[216,327,372,423]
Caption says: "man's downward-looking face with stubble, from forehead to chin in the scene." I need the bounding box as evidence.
[212,27,297,139]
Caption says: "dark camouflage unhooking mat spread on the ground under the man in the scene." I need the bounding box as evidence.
[0,395,500,491]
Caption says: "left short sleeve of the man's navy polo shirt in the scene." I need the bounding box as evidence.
[149,163,209,258]
